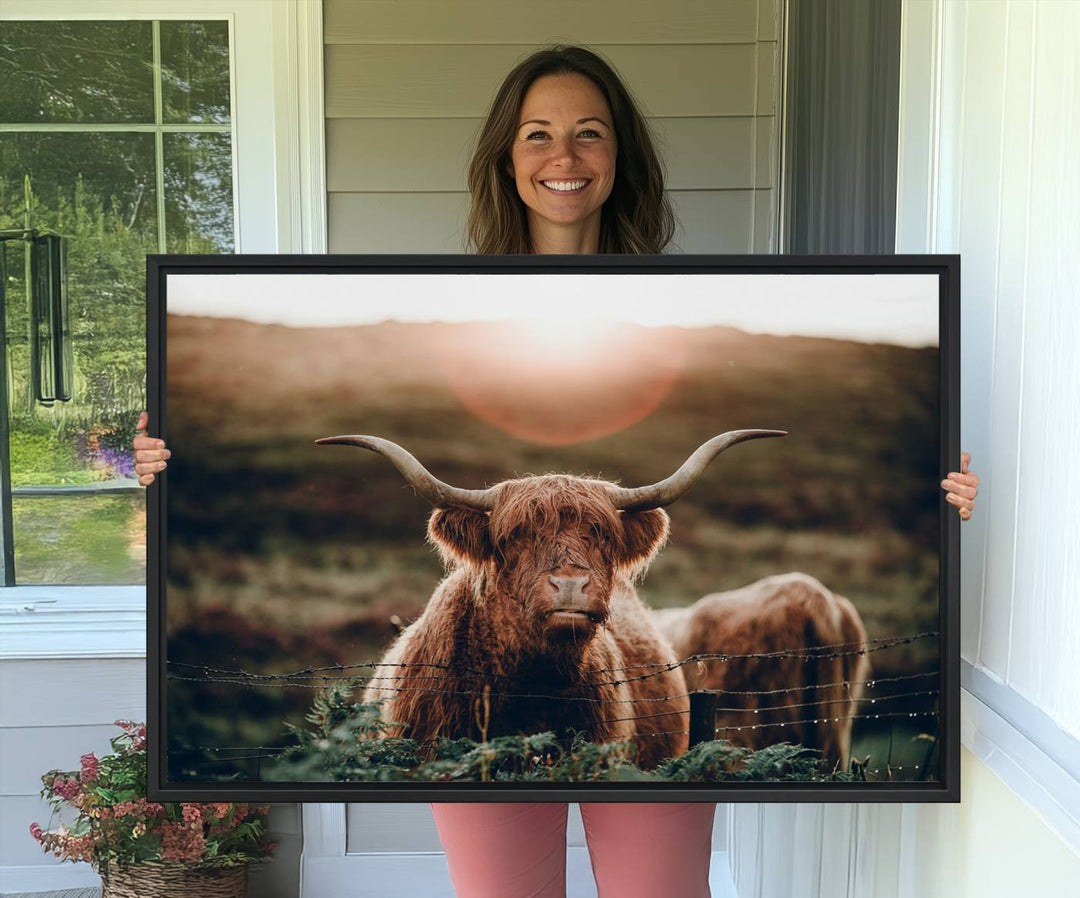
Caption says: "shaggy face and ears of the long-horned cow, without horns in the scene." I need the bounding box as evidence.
[428,474,667,644]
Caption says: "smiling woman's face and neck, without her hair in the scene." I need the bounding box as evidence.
[510,75,616,239]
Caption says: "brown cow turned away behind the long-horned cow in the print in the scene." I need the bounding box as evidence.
[652,573,870,769]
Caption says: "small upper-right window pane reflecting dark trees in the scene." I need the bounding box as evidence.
[161,22,229,124]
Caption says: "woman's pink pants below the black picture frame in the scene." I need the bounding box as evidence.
[431,802,716,898]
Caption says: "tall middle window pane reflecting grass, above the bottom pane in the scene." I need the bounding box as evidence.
[0,133,157,486]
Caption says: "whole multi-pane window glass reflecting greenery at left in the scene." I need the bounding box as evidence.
[0,19,237,585]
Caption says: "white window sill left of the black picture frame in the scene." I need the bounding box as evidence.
[0,586,146,659]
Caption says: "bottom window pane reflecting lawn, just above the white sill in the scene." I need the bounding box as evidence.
[12,490,146,586]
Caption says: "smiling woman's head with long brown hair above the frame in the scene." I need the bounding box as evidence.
[468,46,675,254]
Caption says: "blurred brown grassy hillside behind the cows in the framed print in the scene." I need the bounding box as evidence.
[167,317,940,776]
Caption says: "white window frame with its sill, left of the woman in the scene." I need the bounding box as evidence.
[0,0,326,659]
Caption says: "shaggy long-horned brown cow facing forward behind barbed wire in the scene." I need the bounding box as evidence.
[318,430,783,766]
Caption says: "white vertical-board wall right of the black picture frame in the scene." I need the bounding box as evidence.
[897,0,1080,738]
